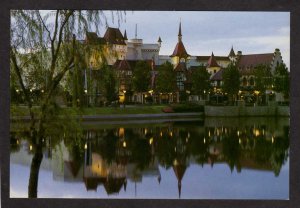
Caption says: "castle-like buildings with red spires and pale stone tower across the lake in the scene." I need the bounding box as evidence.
[79,22,283,102]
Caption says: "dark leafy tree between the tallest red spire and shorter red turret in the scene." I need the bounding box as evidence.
[191,66,210,95]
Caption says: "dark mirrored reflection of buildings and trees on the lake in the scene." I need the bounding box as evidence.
[11,118,289,198]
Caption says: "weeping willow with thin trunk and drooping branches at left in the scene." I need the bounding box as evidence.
[10,10,125,197]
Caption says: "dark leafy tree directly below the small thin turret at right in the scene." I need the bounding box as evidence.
[223,64,240,103]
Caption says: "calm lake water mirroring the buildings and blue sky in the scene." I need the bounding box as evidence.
[10,118,289,199]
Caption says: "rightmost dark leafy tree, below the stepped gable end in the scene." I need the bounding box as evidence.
[274,63,290,98]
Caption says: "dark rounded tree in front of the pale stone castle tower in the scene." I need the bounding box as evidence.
[132,61,151,92]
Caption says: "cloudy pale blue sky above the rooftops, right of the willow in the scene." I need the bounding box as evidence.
[100,11,290,67]
